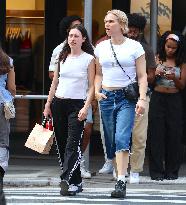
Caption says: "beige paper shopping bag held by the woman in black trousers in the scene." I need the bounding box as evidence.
[25,123,53,154]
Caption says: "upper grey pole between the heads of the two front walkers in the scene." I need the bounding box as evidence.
[84,0,92,41]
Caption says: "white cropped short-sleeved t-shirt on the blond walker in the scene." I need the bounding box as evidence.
[94,38,145,87]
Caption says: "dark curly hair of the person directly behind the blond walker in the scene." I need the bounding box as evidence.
[127,13,147,31]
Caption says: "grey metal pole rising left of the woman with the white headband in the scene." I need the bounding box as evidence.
[150,0,158,54]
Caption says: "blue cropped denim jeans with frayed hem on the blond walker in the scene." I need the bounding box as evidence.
[99,89,136,159]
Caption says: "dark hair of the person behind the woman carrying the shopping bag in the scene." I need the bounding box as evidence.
[59,15,83,41]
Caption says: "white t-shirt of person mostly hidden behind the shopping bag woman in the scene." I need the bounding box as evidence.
[48,41,65,72]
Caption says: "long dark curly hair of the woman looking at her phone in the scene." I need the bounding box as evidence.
[158,31,186,66]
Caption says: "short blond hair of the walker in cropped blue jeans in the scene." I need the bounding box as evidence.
[107,9,129,34]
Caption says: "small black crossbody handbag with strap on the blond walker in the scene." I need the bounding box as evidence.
[110,40,139,101]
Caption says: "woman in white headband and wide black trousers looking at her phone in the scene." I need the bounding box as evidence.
[149,31,186,180]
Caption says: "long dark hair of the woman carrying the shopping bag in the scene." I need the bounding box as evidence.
[59,25,94,63]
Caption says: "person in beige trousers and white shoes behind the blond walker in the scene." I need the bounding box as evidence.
[127,13,156,183]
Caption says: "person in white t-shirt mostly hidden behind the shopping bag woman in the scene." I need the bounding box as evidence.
[49,15,93,178]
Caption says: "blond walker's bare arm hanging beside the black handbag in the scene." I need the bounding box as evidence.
[136,55,148,115]
